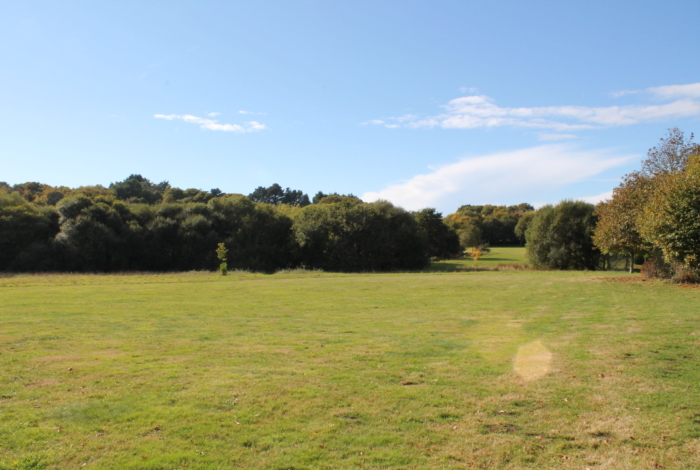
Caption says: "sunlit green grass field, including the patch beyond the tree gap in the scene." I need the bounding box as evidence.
[0,249,700,470]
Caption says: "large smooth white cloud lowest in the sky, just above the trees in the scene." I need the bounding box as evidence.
[362,144,636,210]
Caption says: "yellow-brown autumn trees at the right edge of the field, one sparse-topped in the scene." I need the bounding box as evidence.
[593,128,700,281]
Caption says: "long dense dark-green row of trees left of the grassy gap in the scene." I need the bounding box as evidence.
[0,175,470,272]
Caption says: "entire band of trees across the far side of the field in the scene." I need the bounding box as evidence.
[0,129,700,280]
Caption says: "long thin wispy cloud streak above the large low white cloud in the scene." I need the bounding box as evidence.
[367,83,700,132]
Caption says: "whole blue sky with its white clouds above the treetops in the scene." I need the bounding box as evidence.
[0,0,700,213]
